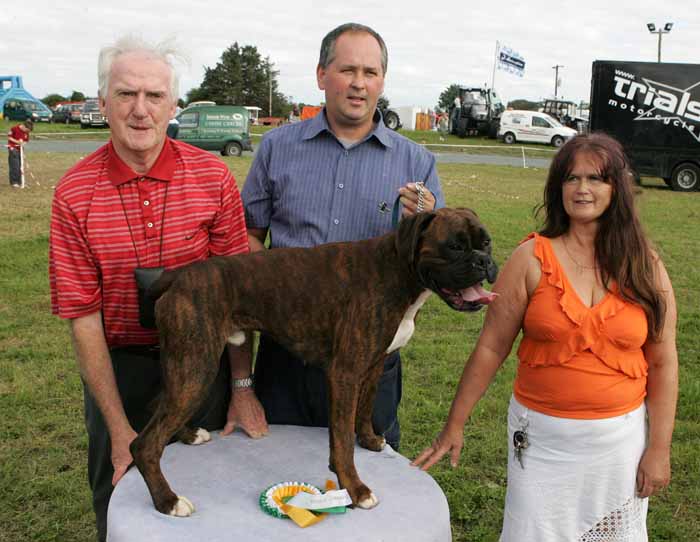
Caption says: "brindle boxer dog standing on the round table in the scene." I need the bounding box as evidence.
[131,209,498,516]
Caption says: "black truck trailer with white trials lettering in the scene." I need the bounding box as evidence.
[590,60,700,191]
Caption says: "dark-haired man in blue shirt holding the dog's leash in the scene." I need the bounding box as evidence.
[235,23,444,449]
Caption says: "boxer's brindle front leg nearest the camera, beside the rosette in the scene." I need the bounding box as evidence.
[326,364,379,508]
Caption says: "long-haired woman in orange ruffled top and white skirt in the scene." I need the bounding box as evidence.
[413,134,678,542]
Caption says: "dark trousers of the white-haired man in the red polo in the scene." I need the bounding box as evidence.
[83,346,231,542]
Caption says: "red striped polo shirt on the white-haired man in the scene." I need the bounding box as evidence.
[49,139,248,347]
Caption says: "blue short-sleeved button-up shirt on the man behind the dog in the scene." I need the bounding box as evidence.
[241,109,445,248]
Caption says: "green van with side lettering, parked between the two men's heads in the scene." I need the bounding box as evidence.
[175,104,253,156]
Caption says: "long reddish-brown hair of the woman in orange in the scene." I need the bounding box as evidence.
[535,133,666,340]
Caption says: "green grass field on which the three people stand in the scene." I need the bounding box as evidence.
[0,153,700,542]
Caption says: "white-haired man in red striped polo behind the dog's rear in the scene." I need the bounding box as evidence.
[49,37,267,540]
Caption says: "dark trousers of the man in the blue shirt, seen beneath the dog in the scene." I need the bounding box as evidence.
[255,334,401,450]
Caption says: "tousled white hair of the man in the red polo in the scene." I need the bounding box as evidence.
[97,35,189,101]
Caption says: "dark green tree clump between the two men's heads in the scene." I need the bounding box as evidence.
[187,42,291,116]
